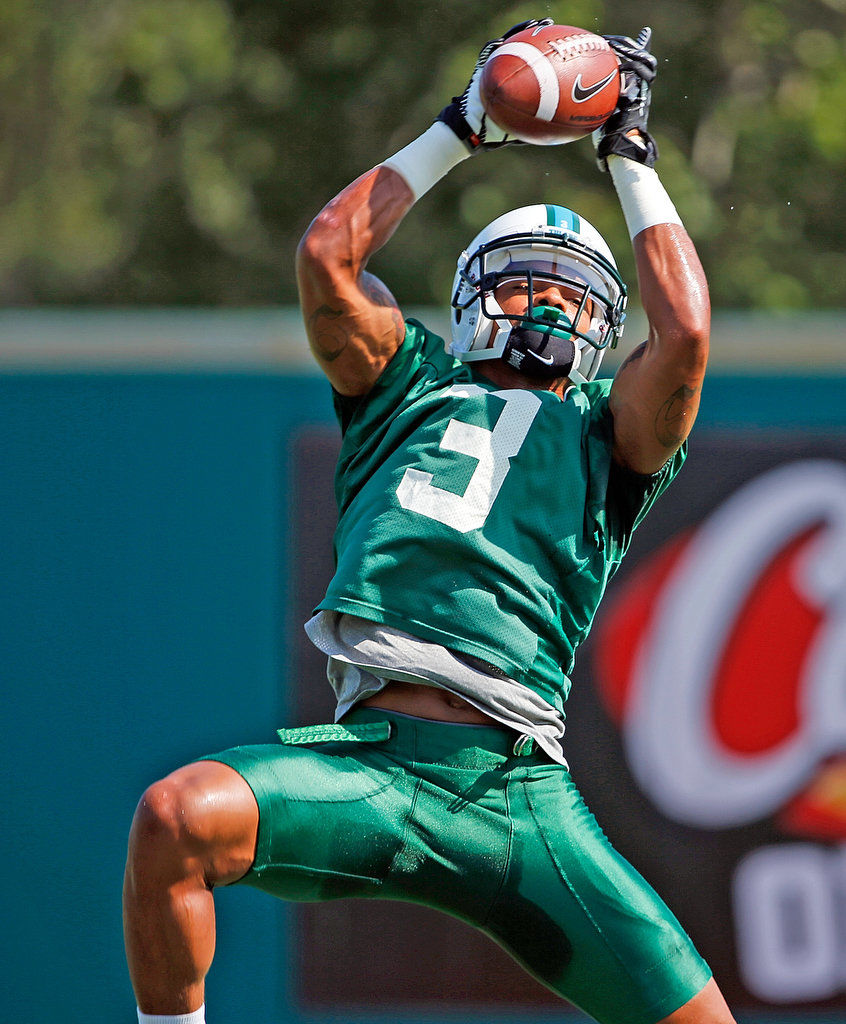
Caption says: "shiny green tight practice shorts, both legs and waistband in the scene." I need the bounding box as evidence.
[200,709,711,1024]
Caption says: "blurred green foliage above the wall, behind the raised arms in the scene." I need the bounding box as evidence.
[0,0,846,309]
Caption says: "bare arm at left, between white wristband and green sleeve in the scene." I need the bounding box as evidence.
[297,166,415,395]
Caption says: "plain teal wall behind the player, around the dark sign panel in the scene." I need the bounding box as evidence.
[0,372,846,1024]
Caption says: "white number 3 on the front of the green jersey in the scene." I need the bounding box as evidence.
[396,384,541,534]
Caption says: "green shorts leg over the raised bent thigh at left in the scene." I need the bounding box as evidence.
[197,743,414,900]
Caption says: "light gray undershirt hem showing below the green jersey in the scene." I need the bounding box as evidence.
[305,611,566,765]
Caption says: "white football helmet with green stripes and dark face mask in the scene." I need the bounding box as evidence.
[450,204,627,383]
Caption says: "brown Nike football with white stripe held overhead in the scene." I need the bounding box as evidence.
[479,25,620,145]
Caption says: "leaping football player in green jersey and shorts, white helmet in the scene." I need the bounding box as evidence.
[125,19,732,1024]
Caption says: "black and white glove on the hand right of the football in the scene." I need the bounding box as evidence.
[593,28,658,171]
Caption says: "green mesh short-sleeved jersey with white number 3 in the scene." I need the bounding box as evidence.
[319,319,685,711]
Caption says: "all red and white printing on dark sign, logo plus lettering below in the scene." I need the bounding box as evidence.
[594,459,846,1006]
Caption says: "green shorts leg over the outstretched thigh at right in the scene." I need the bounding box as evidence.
[489,765,711,1024]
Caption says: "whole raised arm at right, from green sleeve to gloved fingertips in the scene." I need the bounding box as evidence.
[597,30,711,473]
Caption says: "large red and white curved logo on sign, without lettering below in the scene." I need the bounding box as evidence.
[597,460,846,838]
